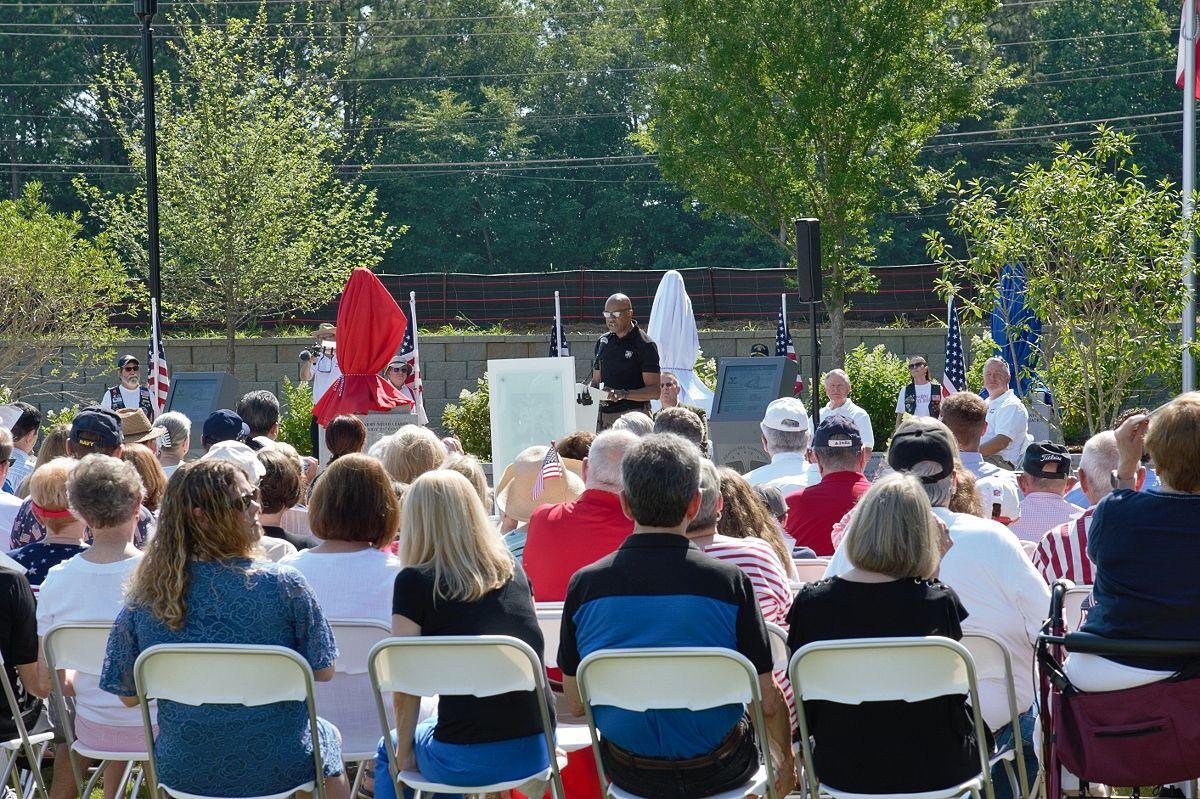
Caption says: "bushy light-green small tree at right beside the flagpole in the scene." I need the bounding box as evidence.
[929,127,1192,433]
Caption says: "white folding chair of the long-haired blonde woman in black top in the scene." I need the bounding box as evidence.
[367,636,565,799]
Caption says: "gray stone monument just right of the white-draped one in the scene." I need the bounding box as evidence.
[708,358,797,474]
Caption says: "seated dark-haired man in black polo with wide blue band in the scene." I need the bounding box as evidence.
[558,434,794,799]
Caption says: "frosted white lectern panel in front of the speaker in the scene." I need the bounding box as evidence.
[487,358,578,474]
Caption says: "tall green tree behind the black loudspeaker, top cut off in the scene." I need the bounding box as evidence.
[644,0,1004,357]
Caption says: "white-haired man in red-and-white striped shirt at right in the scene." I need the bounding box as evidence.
[1033,429,1146,585]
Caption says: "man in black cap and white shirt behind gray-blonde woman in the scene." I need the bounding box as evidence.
[826,417,1050,799]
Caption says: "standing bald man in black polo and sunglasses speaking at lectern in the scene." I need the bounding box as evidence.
[592,294,659,433]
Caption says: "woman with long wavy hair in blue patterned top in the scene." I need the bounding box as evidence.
[100,461,349,799]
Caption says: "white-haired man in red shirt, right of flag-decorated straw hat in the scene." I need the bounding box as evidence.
[521,429,638,602]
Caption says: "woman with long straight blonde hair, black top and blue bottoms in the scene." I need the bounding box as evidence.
[376,469,548,799]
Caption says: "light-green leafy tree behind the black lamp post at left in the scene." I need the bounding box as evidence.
[77,7,396,371]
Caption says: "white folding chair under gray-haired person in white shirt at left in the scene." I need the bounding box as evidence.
[42,621,146,797]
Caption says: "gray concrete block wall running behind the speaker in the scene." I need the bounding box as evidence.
[26,328,946,426]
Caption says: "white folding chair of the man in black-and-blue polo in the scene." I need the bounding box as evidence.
[575,647,776,799]
